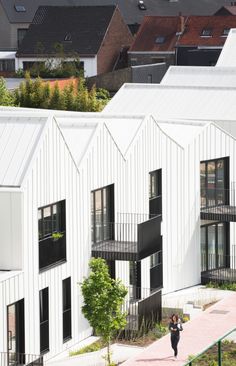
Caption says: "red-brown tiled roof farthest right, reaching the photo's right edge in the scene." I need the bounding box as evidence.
[177,15,236,46]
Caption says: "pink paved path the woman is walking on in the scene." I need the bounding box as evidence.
[122,293,236,366]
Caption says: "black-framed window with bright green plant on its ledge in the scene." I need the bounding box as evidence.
[38,200,66,270]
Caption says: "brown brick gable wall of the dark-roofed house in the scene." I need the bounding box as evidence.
[97,8,133,74]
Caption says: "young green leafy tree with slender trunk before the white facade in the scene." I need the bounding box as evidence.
[81,258,127,365]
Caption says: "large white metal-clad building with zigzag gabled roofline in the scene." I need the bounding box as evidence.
[0,25,236,366]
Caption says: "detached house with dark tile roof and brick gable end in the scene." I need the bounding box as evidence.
[16,5,133,76]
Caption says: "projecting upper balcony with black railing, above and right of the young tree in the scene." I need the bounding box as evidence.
[92,214,162,261]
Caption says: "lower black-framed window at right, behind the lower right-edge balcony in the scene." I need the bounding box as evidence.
[201,222,229,271]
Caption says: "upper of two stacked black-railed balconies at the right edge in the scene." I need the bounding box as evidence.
[201,188,236,222]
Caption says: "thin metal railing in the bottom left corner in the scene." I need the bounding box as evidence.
[0,352,43,366]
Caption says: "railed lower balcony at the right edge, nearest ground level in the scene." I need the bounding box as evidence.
[201,254,236,284]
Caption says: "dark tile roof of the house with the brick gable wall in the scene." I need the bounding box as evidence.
[17,5,116,56]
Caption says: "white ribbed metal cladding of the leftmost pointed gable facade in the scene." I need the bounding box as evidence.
[19,119,91,359]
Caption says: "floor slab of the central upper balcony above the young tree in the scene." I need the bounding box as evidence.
[92,240,138,261]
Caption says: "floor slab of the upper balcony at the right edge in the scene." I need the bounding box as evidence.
[201,205,236,221]
